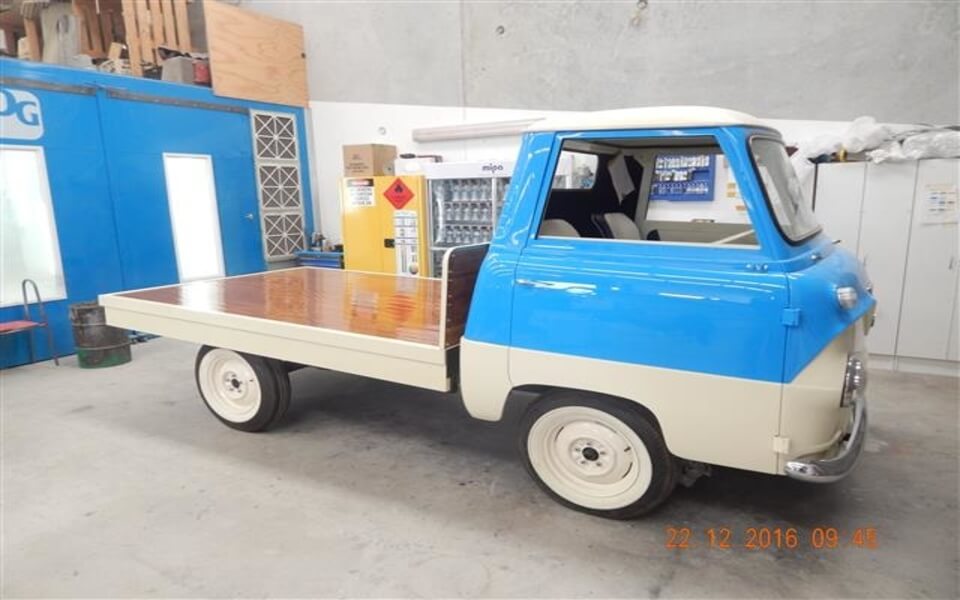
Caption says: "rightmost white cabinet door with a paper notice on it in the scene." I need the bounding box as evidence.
[897,159,960,360]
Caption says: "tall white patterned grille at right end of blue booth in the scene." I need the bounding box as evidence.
[250,111,306,261]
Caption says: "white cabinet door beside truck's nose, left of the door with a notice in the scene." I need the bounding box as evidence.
[857,162,917,354]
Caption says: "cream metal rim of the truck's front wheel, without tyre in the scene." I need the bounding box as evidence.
[527,406,653,510]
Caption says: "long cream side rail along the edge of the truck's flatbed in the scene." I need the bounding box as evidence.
[100,294,451,392]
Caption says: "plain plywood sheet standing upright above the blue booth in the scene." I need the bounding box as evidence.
[203,1,308,106]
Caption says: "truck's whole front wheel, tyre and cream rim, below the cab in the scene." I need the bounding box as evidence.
[520,392,676,519]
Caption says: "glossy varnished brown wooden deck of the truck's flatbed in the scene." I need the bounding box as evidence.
[117,267,443,346]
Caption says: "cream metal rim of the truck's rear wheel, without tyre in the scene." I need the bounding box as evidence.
[197,348,261,423]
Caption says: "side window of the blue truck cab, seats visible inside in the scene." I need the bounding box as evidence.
[539,138,757,247]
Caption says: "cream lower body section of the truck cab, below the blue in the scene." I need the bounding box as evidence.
[460,328,863,474]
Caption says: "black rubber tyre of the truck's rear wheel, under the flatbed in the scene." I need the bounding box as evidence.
[194,346,290,433]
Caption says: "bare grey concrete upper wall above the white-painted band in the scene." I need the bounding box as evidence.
[240,0,960,123]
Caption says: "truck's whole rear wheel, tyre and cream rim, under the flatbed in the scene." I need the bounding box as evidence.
[195,346,290,432]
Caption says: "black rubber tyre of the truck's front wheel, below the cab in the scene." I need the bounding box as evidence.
[519,391,678,519]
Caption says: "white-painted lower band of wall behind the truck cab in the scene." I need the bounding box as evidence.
[310,102,864,242]
